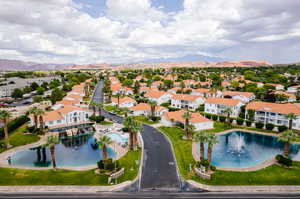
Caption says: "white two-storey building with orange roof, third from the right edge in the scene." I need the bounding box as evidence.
[171,94,205,110]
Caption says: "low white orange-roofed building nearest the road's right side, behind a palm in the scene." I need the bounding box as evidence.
[161,110,214,131]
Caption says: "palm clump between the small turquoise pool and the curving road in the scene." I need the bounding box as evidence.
[123,117,143,150]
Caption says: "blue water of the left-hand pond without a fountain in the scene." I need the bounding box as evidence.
[11,135,115,167]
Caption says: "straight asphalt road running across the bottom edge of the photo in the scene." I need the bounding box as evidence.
[0,192,300,199]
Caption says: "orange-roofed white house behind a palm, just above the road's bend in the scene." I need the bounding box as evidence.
[130,103,168,117]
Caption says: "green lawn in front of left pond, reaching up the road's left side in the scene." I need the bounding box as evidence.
[0,150,141,185]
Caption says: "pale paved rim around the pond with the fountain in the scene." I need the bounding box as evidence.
[192,129,300,172]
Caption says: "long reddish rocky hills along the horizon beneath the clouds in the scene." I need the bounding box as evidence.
[0,58,272,71]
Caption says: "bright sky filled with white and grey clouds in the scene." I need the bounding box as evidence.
[0,0,300,64]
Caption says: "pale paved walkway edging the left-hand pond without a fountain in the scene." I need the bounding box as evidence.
[0,133,128,171]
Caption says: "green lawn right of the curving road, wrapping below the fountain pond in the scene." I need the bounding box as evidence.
[159,127,300,185]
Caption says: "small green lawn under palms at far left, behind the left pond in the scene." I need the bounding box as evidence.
[0,124,40,152]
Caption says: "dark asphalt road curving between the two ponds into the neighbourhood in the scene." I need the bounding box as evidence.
[93,82,181,191]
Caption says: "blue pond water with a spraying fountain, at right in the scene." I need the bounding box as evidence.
[197,131,300,168]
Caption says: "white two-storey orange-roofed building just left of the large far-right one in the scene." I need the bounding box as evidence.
[204,98,244,117]
